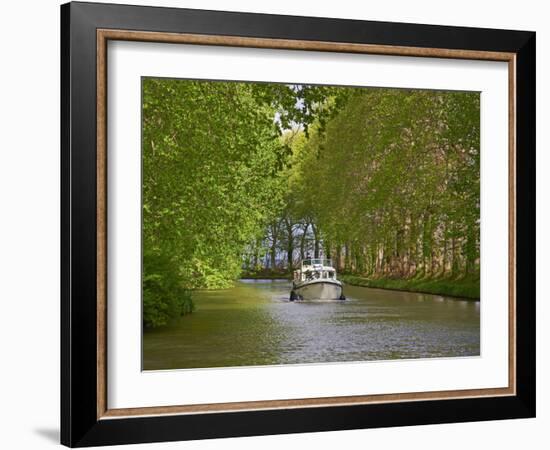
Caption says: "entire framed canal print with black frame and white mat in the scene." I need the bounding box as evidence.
[61,3,535,446]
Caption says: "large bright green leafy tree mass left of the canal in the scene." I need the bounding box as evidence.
[142,78,300,324]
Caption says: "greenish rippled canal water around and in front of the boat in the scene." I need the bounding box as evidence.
[143,280,480,370]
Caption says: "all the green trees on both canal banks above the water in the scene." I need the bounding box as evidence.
[142,78,480,320]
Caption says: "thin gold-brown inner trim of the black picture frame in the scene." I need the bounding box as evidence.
[96,29,516,420]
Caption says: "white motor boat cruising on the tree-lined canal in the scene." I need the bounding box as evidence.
[290,258,346,301]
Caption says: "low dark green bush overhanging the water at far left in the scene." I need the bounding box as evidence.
[143,254,195,327]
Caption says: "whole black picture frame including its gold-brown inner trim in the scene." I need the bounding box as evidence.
[61,2,536,447]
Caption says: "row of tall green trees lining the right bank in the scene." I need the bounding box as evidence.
[296,88,480,278]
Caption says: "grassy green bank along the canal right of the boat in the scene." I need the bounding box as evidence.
[339,274,479,300]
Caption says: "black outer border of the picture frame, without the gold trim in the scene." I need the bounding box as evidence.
[61,2,535,447]
